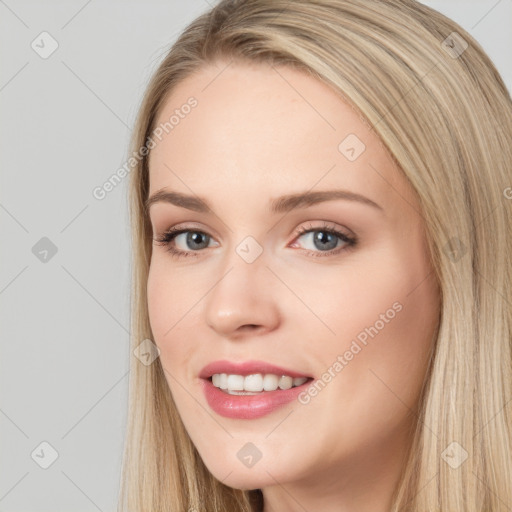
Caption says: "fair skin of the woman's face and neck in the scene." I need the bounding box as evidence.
[148,61,439,512]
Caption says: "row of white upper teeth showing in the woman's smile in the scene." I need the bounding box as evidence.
[212,373,308,395]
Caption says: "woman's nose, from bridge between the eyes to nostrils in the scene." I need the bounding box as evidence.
[205,236,279,335]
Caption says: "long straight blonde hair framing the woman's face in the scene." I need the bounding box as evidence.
[118,0,512,512]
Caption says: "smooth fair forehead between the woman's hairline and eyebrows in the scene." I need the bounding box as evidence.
[149,61,411,213]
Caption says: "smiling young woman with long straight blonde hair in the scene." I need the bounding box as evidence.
[119,0,512,512]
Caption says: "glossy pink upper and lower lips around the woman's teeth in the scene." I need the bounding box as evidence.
[199,360,311,419]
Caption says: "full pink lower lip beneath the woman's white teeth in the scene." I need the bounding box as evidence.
[202,379,311,420]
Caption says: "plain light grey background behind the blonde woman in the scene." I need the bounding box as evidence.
[0,0,512,512]
